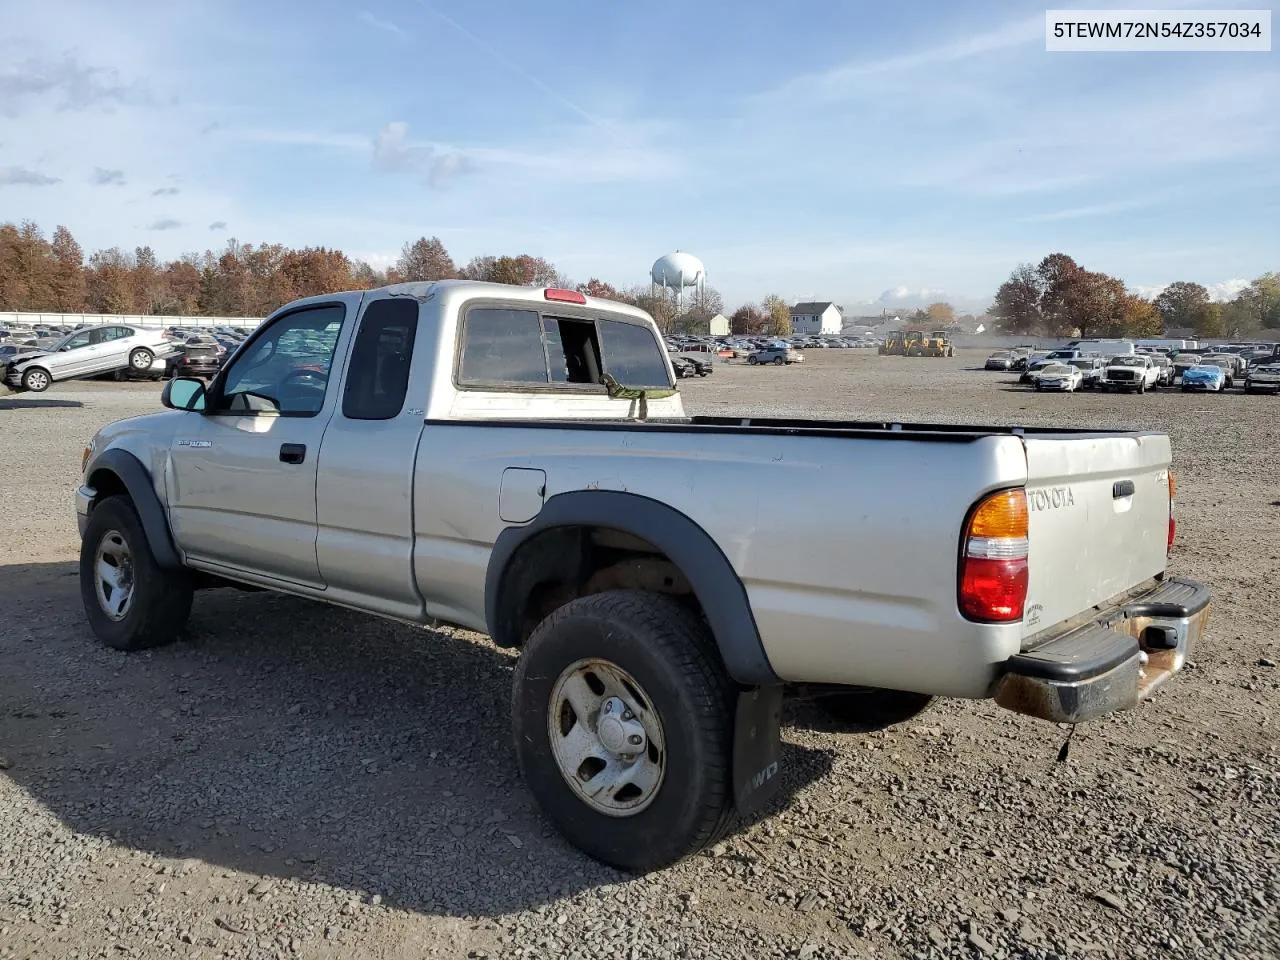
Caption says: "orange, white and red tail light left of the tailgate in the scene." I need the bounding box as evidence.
[960,489,1028,623]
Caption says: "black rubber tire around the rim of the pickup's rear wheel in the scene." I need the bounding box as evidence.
[512,590,735,872]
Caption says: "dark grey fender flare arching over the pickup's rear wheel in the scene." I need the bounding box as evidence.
[484,490,780,686]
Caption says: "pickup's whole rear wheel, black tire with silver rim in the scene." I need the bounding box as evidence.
[512,590,733,872]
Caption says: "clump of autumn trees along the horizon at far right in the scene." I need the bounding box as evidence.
[988,253,1280,337]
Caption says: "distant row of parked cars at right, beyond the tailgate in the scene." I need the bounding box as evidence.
[984,344,1280,393]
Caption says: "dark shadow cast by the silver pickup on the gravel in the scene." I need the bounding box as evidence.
[0,563,833,916]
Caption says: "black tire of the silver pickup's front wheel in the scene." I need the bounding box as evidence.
[79,497,192,652]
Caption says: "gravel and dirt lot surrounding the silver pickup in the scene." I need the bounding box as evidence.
[0,351,1280,960]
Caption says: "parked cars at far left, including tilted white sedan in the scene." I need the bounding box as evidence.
[0,324,248,393]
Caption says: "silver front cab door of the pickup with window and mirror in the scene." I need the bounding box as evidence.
[166,293,362,588]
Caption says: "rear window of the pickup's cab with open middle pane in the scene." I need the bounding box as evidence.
[457,305,673,393]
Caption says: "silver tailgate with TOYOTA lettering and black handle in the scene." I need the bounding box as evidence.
[1023,434,1171,636]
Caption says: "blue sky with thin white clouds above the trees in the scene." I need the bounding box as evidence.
[0,0,1280,312]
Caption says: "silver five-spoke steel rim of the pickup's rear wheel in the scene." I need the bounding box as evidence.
[547,658,667,817]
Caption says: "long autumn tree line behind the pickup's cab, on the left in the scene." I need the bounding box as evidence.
[0,220,727,332]
